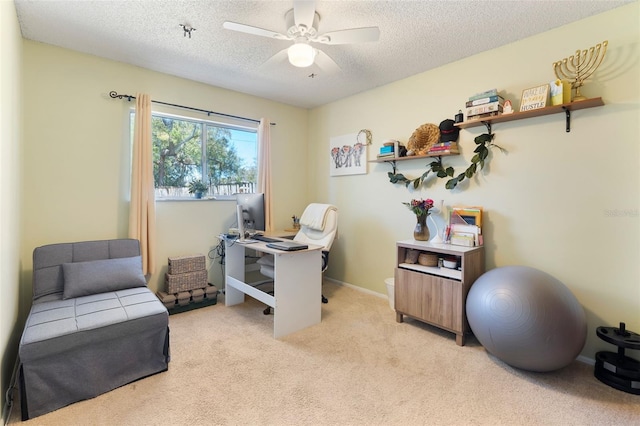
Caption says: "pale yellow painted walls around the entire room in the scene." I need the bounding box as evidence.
[0,2,640,410]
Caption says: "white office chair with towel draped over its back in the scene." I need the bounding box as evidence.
[257,203,338,314]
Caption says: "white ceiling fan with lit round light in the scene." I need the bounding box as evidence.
[223,0,380,71]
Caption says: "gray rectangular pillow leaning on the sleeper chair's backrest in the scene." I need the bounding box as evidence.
[62,256,147,299]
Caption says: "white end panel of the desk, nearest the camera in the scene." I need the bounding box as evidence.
[273,250,322,338]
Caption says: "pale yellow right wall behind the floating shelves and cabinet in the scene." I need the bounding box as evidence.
[308,2,640,358]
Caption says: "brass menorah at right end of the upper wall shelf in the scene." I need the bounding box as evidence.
[553,40,609,101]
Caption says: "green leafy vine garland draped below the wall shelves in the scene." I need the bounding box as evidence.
[388,133,505,189]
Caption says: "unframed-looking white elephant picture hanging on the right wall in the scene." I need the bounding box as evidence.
[329,133,367,176]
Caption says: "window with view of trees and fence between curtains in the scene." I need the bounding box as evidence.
[131,112,258,199]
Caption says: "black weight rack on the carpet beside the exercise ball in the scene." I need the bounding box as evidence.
[594,322,640,395]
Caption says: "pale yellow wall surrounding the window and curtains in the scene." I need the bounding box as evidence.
[21,40,308,290]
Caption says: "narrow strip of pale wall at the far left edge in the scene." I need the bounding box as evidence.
[0,1,22,415]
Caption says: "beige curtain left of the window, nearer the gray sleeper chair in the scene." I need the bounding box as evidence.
[129,93,156,275]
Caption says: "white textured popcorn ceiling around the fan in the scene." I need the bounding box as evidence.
[14,0,632,108]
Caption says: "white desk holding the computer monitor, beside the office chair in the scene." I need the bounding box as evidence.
[225,239,322,338]
